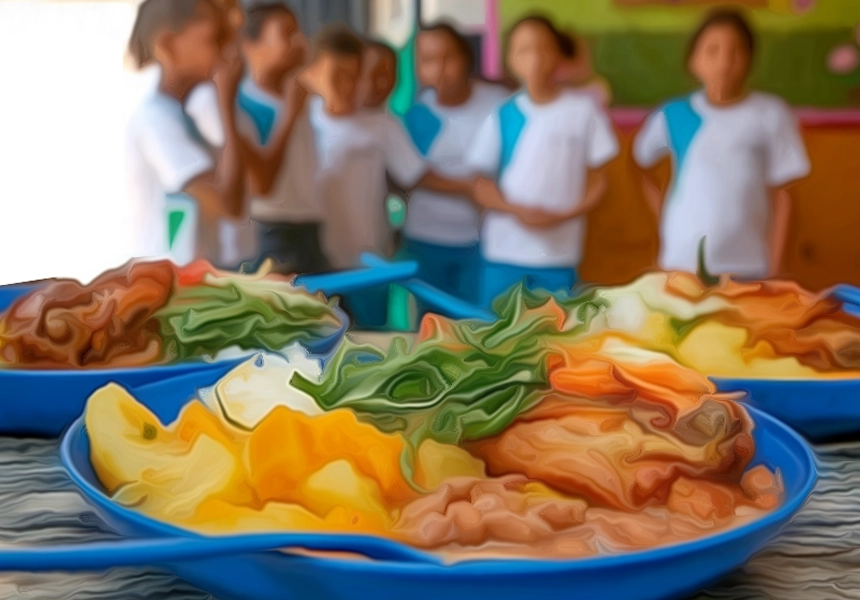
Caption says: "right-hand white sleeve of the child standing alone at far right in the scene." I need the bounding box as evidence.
[766,102,810,187]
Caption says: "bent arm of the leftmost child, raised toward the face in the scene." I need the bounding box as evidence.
[185,54,245,218]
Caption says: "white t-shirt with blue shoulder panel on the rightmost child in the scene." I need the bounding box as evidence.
[634,92,810,278]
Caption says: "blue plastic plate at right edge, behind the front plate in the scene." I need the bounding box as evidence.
[711,377,860,440]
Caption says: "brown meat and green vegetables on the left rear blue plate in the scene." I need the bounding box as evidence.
[0,261,342,369]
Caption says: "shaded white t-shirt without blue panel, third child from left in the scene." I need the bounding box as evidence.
[309,97,426,269]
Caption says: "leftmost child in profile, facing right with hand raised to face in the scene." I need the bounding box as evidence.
[127,0,244,263]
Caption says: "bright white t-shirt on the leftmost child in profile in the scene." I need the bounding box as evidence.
[126,90,215,263]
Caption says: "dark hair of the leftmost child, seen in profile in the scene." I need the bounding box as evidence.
[128,0,209,68]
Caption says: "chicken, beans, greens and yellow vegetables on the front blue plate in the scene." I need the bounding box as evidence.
[85,296,783,561]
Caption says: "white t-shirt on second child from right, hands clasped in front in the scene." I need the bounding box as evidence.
[468,90,618,267]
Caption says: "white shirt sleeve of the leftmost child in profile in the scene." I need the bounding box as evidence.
[138,105,215,194]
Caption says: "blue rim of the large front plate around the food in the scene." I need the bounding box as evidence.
[60,406,818,575]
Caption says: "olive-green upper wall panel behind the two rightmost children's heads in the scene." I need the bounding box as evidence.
[499,0,860,108]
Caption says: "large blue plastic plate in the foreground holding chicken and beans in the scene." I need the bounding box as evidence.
[57,400,816,600]
